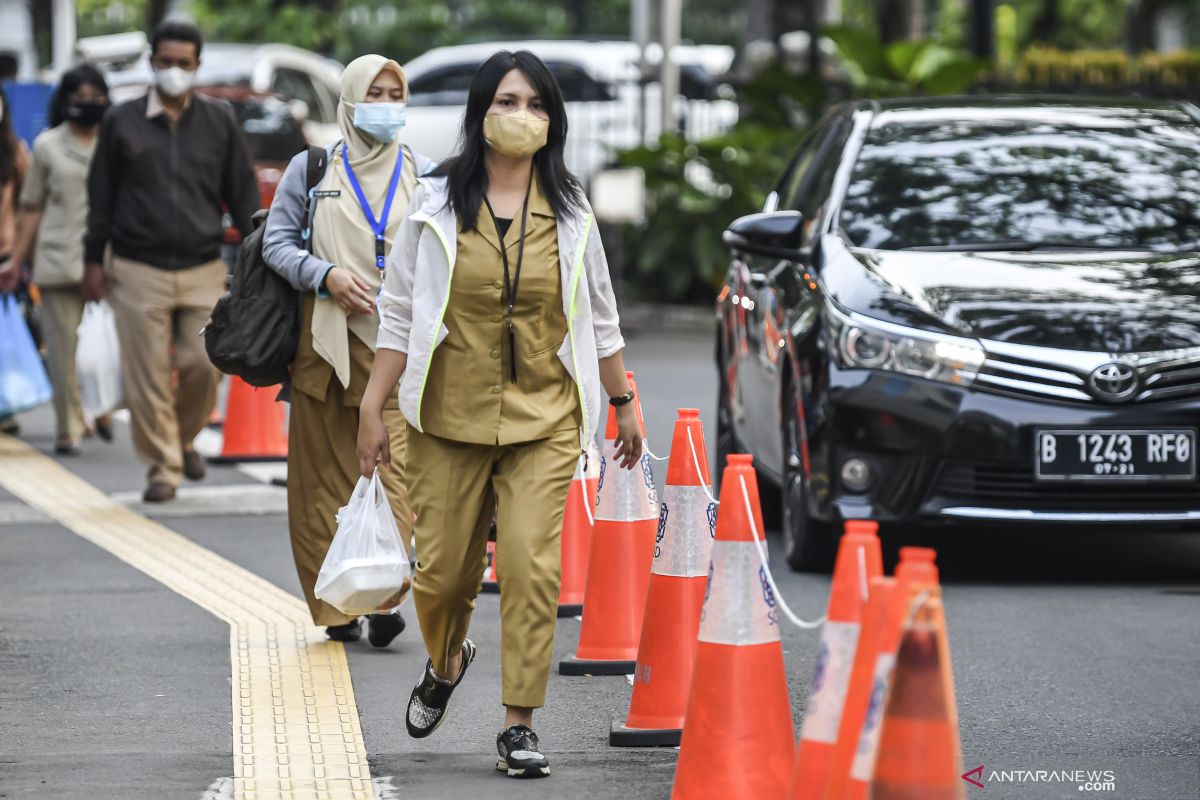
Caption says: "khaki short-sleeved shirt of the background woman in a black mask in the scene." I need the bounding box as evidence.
[20,122,96,287]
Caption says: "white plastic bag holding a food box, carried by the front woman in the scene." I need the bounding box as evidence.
[313,471,412,616]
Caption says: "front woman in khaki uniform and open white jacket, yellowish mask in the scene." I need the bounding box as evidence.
[359,52,642,777]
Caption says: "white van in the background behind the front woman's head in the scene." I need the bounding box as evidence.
[401,41,738,181]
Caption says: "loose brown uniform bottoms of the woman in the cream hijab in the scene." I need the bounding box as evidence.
[288,378,413,626]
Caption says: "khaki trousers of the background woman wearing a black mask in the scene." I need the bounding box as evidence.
[40,284,84,443]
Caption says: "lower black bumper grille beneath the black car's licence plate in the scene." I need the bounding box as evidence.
[935,461,1200,512]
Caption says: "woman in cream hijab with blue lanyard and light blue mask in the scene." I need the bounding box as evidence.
[263,55,433,648]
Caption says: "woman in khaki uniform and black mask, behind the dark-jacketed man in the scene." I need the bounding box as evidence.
[8,65,113,456]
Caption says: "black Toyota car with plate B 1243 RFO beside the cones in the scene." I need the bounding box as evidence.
[716,97,1200,569]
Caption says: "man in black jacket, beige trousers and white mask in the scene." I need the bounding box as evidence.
[84,22,258,503]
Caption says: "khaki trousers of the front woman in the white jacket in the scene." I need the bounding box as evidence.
[406,426,580,708]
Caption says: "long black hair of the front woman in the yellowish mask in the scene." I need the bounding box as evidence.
[433,50,583,230]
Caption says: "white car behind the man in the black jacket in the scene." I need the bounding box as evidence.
[95,37,342,145]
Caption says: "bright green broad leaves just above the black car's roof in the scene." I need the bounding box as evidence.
[826,25,988,97]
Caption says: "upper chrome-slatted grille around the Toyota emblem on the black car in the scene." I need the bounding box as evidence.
[976,342,1200,404]
